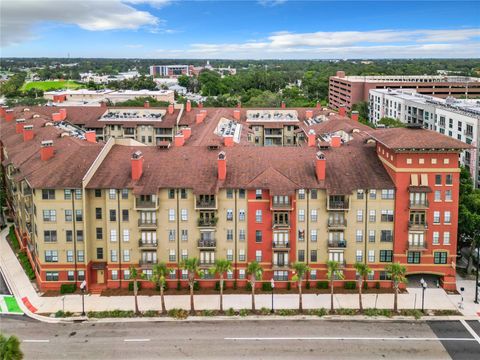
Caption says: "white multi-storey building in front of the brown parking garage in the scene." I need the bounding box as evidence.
[369,89,480,188]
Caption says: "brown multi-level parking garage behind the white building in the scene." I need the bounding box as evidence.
[328,71,480,110]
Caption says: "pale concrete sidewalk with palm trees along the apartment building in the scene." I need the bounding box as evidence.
[0,226,480,317]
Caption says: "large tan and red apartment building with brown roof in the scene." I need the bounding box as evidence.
[0,103,470,292]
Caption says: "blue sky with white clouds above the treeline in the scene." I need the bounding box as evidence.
[0,0,480,59]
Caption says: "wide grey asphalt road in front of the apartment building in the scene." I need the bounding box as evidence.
[0,316,480,360]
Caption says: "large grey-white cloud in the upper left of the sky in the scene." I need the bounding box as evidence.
[0,0,170,46]
